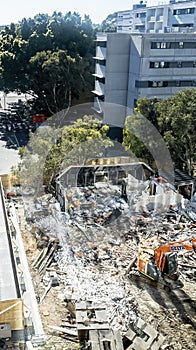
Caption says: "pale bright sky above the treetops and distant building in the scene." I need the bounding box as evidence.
[0,0,158,25]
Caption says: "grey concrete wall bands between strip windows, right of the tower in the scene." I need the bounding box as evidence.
[138,34,196,98]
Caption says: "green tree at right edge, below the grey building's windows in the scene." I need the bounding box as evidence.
[157,89,196,175]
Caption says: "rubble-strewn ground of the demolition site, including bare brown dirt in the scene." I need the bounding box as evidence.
[17,186,196,350]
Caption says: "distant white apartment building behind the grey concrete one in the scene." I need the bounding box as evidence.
[117,0,196,33]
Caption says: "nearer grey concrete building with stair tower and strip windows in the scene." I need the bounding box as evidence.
[93,33,196,128]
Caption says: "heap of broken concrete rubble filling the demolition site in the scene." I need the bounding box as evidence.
[21,173,196,350]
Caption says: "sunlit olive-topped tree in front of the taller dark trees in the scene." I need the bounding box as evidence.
[29,50,88,114]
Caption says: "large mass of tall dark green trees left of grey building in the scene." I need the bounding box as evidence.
[0,12,95,115]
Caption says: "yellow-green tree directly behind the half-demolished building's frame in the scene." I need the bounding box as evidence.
[21,116,113,194]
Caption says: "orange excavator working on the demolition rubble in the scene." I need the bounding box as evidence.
[137,238,196,290]
